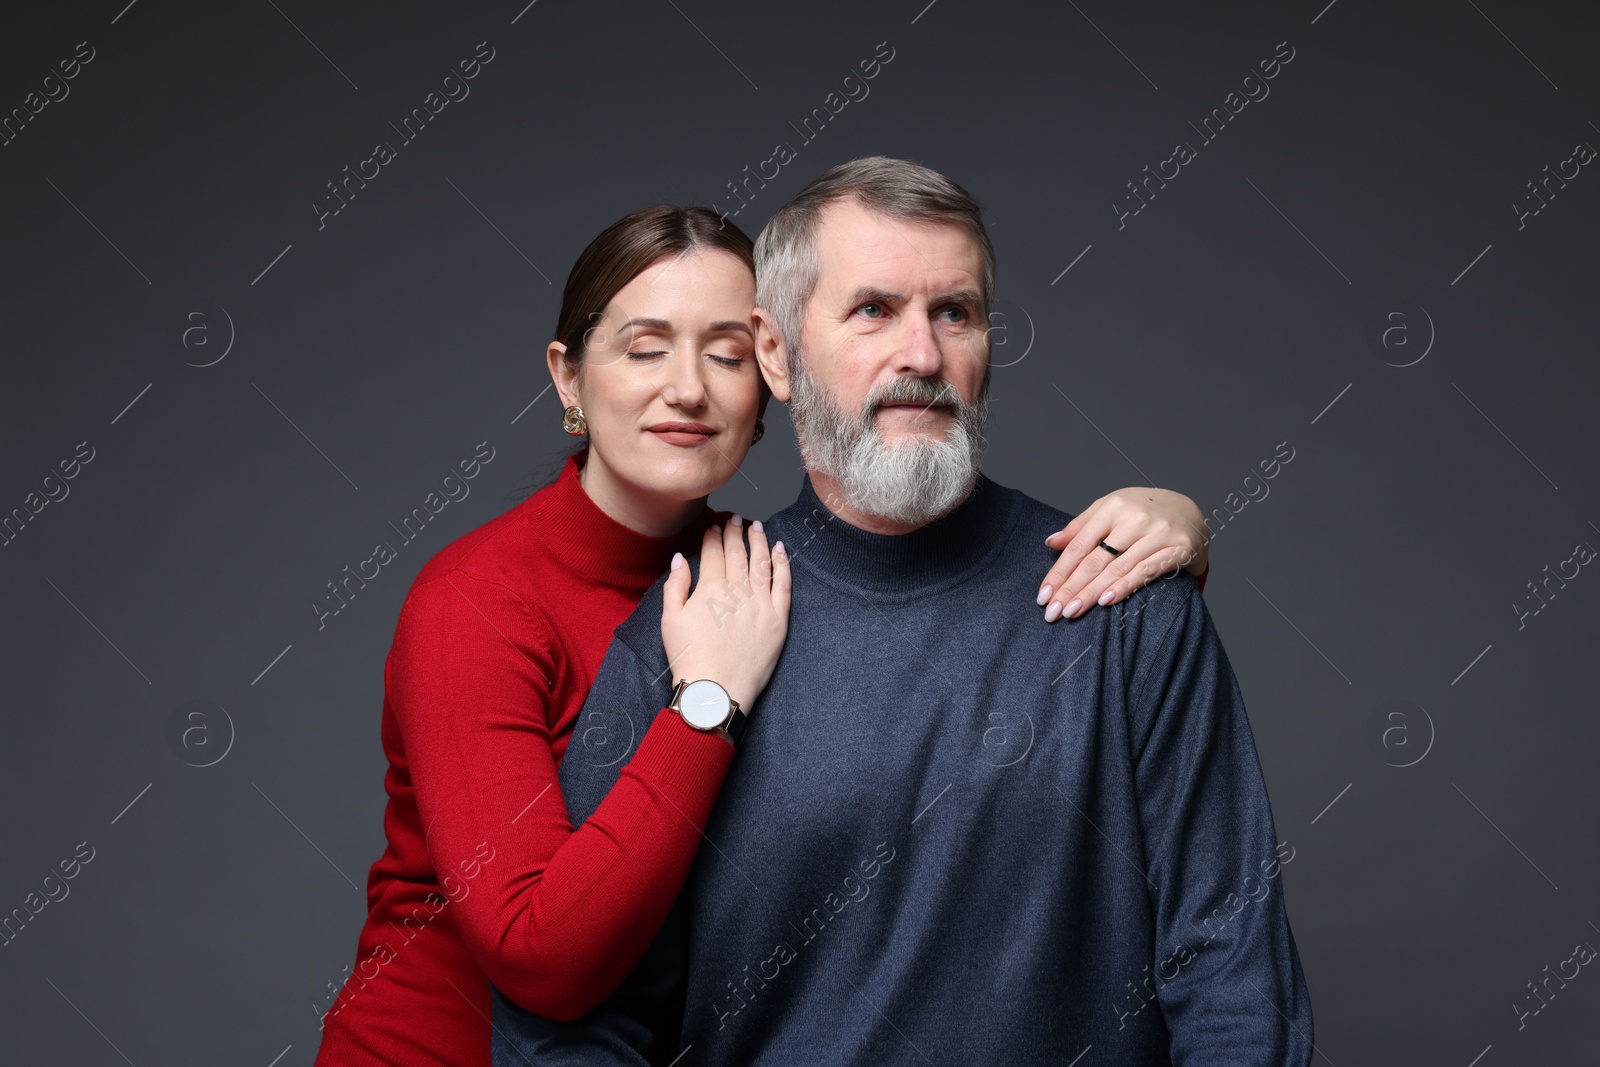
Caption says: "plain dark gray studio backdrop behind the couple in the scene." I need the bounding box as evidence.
[0,0,1600,1067]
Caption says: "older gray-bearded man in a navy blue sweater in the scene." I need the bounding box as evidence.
[496,158,1312,1067]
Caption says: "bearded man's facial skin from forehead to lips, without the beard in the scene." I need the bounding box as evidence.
[800,200,989,445]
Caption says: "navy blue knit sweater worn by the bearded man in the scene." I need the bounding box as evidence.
[494,478,1312,1067]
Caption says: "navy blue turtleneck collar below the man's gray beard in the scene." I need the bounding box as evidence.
[768,475,1018,597]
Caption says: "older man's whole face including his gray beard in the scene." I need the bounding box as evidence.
[771,202,989,533]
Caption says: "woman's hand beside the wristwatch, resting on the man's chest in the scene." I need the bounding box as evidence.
[661,515,790,712]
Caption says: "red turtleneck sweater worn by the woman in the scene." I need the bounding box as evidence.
[317,454,733,1067]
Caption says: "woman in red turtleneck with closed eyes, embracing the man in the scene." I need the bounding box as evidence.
[317,206,1205,1067]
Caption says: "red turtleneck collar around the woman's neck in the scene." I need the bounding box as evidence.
[523,450,714,593]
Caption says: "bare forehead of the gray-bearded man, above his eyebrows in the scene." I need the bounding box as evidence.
[816,200,982,288]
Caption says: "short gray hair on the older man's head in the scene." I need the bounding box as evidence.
[755,155,995,360]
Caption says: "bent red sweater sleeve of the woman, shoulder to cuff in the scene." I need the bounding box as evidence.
[390,571,733,1021]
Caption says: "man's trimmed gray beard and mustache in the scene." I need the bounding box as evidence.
[789,354,989,526]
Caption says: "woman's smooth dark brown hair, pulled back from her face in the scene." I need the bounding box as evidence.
[555,203,755,366]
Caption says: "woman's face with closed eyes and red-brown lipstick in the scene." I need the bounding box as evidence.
[550,250,760,515]
